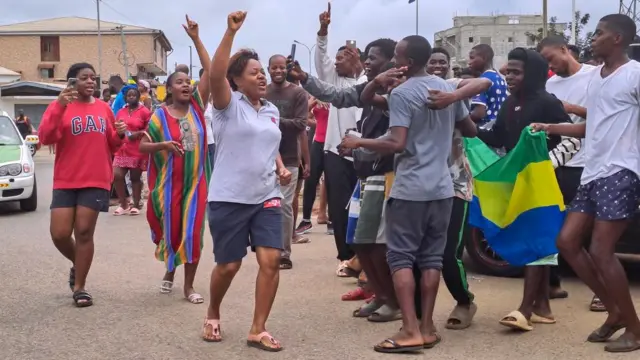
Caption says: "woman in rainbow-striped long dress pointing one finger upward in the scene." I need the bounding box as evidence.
[140,17,211,304]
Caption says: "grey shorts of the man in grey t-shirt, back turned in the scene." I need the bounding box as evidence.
[385,198,453,273]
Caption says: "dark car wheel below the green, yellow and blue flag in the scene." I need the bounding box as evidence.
[465,226,523,277]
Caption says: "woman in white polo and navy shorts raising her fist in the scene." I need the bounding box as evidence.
[202,12,291,352]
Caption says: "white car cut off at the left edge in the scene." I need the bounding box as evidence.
[0,112,39,211]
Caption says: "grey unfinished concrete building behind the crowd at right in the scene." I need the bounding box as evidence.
[434,15,567,68]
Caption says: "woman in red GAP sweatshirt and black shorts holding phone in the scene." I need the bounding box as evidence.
[38,63,126,307]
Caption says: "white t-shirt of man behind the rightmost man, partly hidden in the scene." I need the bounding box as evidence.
[547,64,596,167]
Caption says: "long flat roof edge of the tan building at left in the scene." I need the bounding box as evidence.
[0,16,172,51]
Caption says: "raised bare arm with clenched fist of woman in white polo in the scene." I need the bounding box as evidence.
[205,11,247,110]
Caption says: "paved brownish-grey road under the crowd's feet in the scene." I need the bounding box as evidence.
[0,154,640,360]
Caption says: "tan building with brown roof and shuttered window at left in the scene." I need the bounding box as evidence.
[0,17,172,82]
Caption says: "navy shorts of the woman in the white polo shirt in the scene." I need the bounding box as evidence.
[208,199,284,264]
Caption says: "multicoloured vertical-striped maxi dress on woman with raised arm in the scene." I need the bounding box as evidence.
[147,88,211,271]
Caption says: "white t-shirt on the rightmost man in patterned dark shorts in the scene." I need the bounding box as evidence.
[580,60,640,185]
